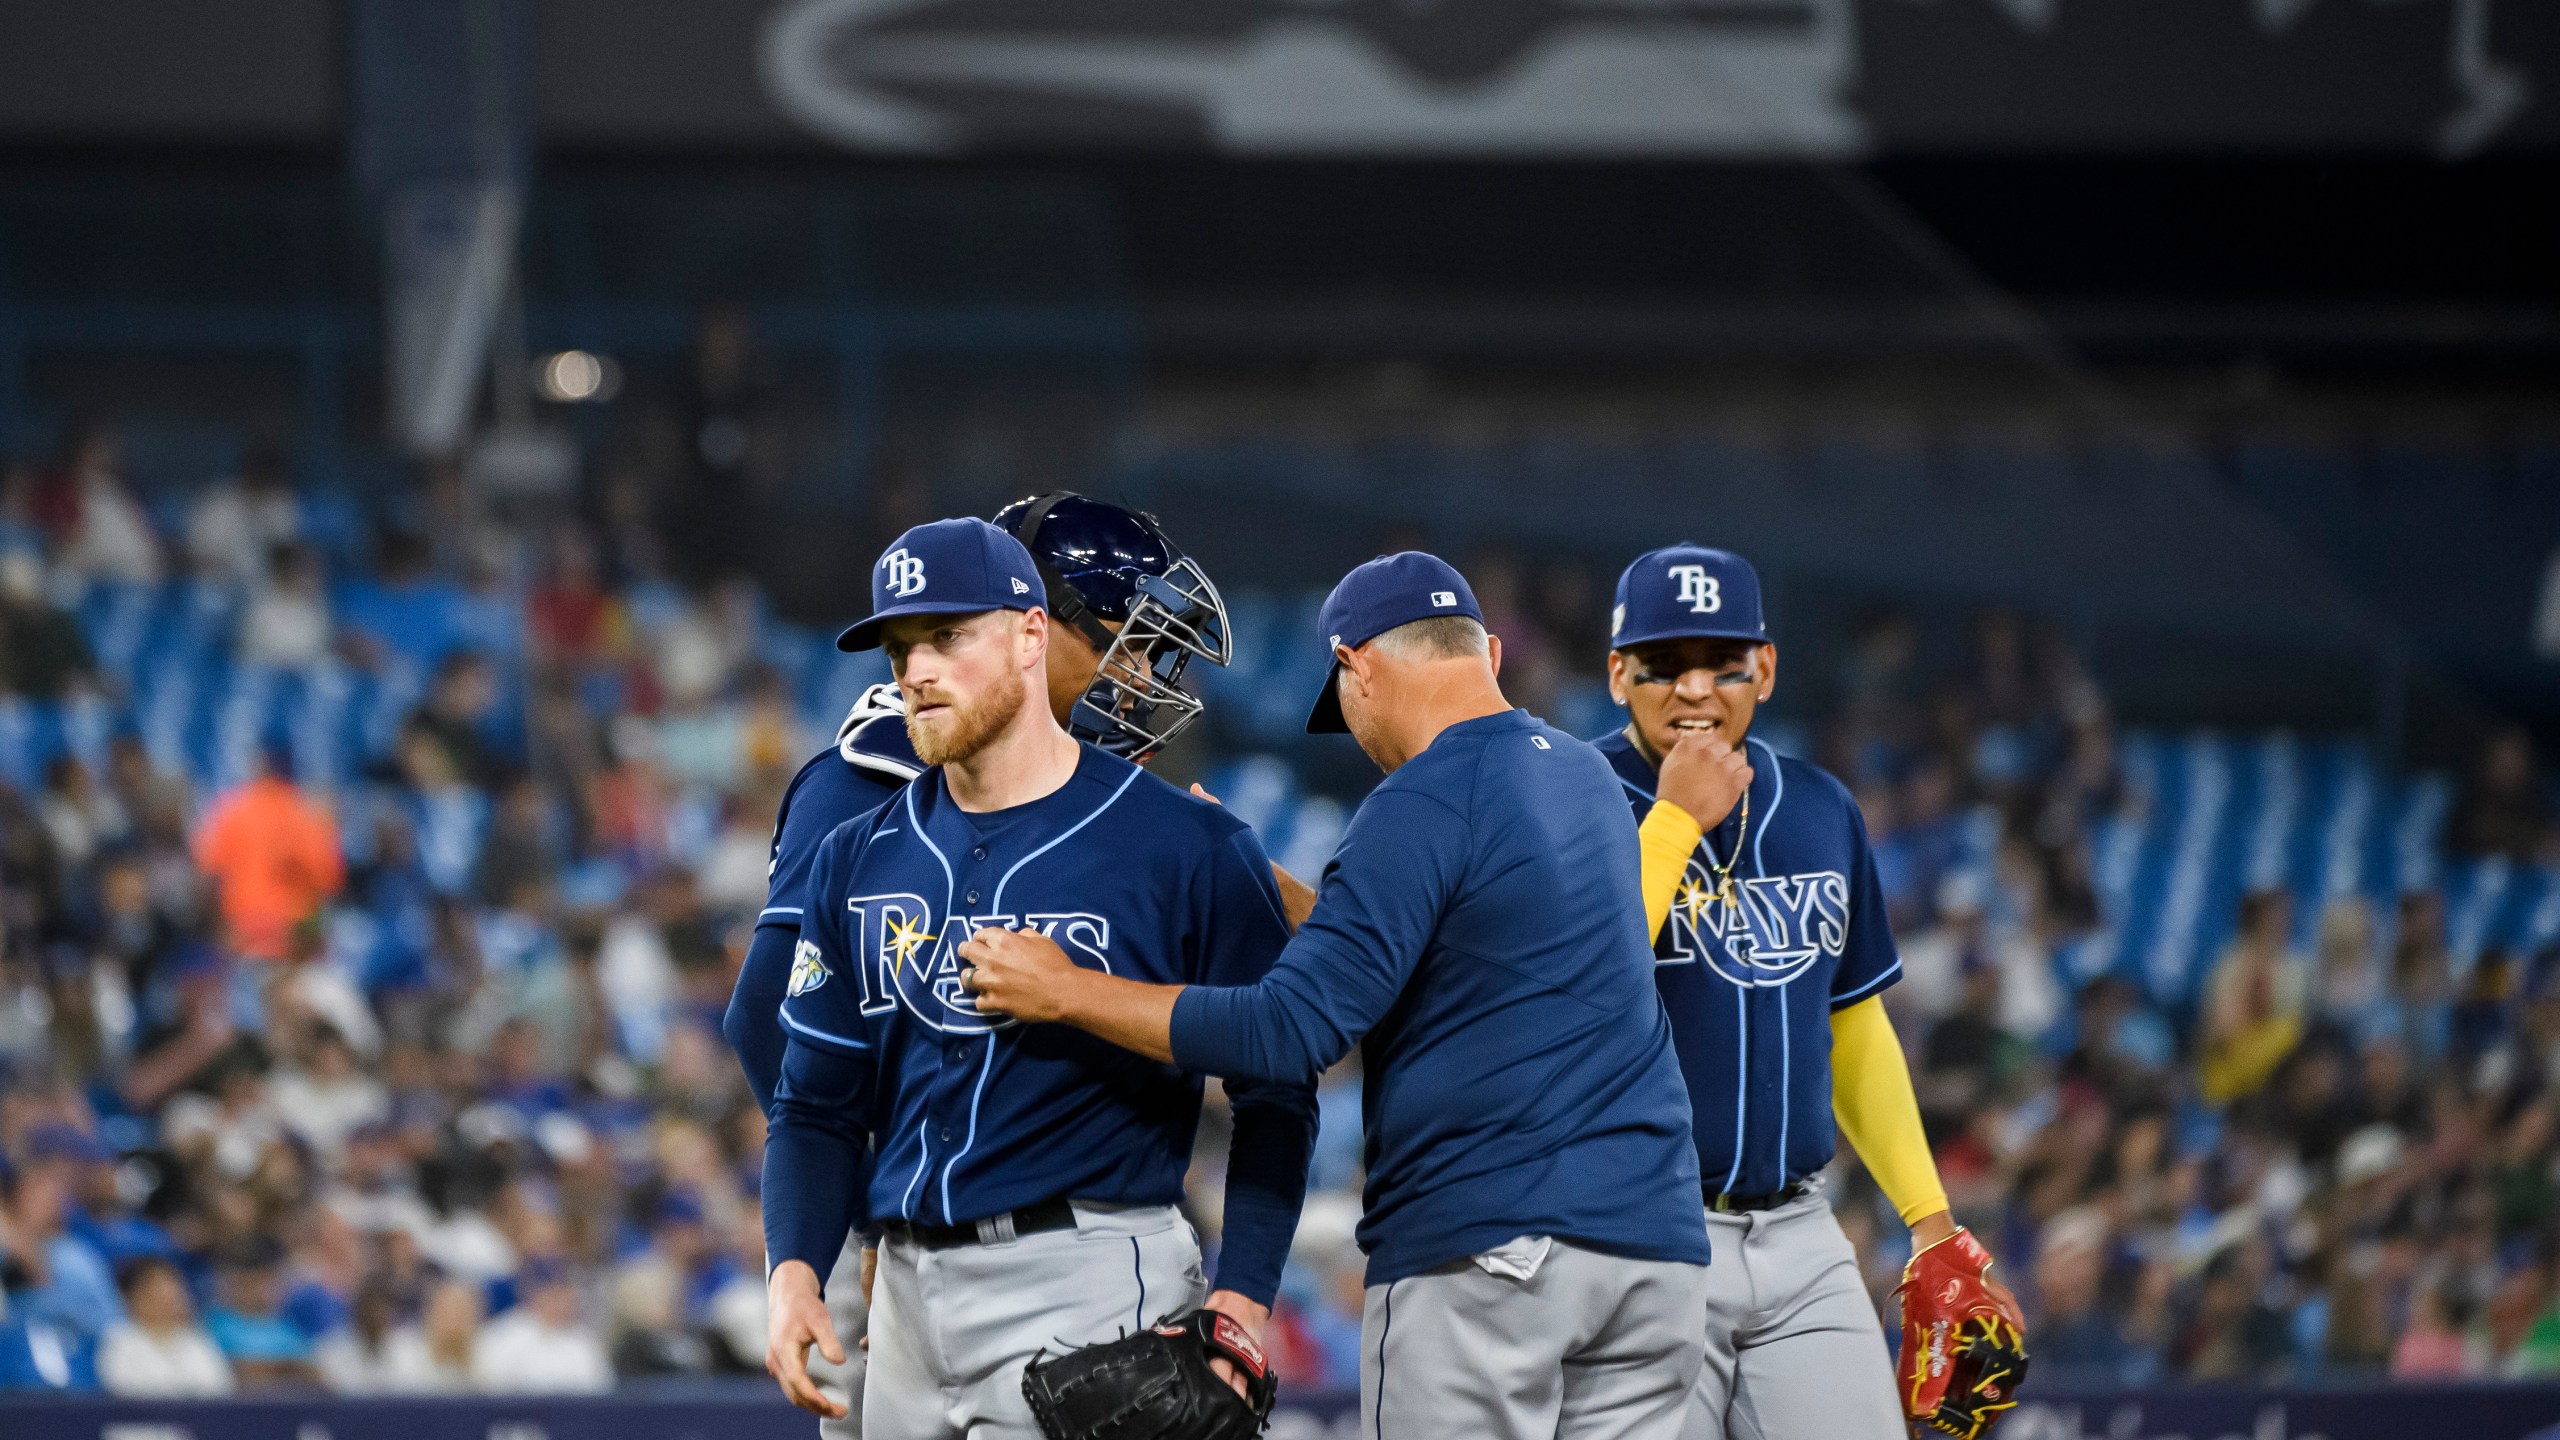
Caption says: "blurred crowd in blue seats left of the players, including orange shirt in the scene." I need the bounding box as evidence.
[0,417,827,1394]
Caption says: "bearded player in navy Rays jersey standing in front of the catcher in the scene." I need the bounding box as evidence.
[763,520,1316,1440]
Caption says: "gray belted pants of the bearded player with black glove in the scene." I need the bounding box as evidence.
[863,1202,1208,1440]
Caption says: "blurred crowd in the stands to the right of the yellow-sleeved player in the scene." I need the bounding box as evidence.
[1781,612,2560,1384]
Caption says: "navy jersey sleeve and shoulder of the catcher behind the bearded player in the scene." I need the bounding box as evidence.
[719,684,924,1109]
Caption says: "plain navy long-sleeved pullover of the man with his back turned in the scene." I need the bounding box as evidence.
[1172,710,1708,1284]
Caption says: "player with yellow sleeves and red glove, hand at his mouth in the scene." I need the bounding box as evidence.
[1597,546,2025,1440]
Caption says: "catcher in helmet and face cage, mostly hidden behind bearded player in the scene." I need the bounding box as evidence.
[719,489,1259,1440]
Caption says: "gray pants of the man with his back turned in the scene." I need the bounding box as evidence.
[1359,1238,1708,1440]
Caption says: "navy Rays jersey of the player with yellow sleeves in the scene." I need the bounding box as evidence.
[1597,730,1902,1194]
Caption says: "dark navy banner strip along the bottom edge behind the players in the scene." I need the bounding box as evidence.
[0,1384,2560,1440]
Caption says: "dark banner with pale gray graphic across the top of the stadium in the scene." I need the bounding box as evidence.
[0,0,2560,159]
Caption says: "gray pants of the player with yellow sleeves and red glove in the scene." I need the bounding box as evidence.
[1679,1189,1905,1440]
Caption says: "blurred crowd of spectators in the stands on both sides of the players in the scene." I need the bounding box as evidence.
[0,400,2560,1394]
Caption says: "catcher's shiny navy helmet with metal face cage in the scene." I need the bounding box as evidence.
[996,489,1234,764]
